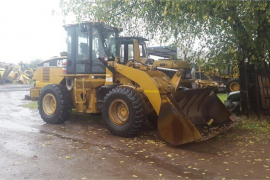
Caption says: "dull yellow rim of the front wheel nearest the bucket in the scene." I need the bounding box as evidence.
[109,99,129,126]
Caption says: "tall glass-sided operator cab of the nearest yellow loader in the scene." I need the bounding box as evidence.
[64,22,120,74]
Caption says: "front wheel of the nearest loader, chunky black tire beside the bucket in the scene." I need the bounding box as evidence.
[102,87,147,137]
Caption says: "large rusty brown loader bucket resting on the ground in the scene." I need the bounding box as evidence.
[158,88,233,145]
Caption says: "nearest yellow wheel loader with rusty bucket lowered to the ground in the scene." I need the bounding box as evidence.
[38,22,233,145]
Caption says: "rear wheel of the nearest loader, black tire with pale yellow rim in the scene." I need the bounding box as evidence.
[38,84,72,124]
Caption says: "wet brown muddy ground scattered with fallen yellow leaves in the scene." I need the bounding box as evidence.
[0,85,270,179]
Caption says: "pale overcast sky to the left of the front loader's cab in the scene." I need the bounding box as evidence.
[0,0,66,63]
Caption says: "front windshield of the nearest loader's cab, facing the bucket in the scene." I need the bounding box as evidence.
[99,26,117,57]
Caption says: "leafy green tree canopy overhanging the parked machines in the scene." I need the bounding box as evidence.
[60,0,270,64]
